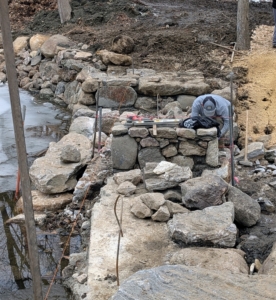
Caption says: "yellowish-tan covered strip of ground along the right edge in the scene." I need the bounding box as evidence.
[235,26,276,147]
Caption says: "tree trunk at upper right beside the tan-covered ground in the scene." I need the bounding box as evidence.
[236,0,250,50]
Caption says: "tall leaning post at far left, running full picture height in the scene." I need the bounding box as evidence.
[0,0,42,300]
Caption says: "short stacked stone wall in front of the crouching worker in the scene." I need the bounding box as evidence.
[111,124,219,170]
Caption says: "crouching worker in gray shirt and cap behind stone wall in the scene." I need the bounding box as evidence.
[191,94,231,148]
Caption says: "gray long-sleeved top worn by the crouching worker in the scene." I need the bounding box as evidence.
[191,94,231,136]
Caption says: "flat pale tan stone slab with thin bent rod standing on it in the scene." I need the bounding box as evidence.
[87,179,177,300]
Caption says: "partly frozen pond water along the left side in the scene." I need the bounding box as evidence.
[0,86,77,300]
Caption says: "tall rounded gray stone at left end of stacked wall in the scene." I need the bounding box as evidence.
[111,135,138,170]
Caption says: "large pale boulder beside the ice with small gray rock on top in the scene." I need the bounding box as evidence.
[30,132,92,194]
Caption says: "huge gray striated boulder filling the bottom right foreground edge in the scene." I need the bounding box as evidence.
[110,265,276,300]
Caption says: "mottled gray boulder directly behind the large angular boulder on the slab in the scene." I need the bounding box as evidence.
[180,174,228,209]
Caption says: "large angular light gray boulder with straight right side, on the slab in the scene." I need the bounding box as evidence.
[168,202,237,247]
